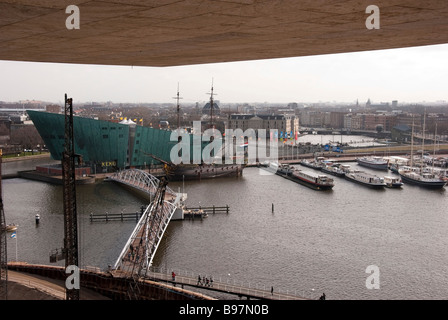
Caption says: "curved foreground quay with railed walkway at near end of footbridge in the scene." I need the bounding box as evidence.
[8,262,308,300]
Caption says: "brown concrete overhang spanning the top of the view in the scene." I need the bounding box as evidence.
[0,0,448,66]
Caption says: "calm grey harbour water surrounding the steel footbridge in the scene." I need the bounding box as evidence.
[3,155,448,299]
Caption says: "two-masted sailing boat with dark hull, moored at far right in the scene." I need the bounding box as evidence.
[398,114,447,189]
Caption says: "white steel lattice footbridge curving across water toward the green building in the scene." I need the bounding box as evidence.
[109,169,183,298]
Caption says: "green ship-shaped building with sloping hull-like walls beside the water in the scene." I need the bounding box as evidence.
[27,110,177,173]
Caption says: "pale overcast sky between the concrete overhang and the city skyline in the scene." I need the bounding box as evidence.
[0,45,448,103]
